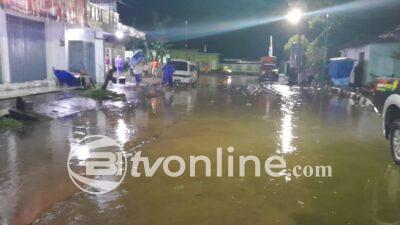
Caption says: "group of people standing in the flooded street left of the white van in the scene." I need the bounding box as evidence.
[104,55,175,87]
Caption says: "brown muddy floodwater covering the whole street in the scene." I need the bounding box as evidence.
[0,76,400,225]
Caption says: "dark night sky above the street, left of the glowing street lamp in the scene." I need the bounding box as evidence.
[118,0,400,60]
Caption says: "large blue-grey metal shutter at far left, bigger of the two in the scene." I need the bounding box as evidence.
[7,15,47,83]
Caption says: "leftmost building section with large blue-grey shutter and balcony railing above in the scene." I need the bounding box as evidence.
[0,0,85,89]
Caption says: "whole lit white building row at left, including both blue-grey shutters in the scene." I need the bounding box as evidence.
[0,0,145,90]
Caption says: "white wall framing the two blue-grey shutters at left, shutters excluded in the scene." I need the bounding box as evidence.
[0,8,120,90]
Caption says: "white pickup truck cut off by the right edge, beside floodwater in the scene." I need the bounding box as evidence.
[374,77,400,165]
